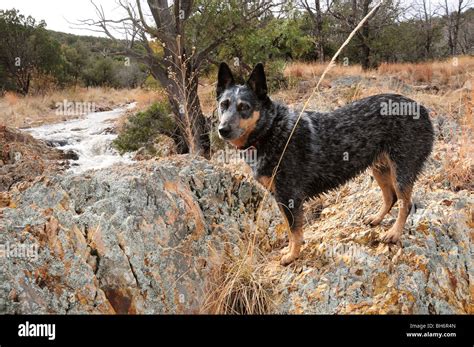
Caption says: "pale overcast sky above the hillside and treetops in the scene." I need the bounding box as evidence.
[0,0,468,36]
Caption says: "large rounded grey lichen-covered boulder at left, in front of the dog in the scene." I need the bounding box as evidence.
[0,156,280,314]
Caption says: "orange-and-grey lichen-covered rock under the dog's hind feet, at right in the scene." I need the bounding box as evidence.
[273,176,474,314]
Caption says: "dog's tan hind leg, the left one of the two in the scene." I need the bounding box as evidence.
[364,165,397,226]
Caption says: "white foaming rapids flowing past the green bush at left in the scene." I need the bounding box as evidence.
[24,104,135,173]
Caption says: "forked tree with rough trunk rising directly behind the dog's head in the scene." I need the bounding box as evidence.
[81,0,277,156]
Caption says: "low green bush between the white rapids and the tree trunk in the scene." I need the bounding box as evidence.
[113,102,177,154]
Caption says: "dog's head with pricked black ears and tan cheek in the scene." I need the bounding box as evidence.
[216,63,269,148]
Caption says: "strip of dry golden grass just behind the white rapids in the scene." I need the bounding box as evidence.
[0,88,162,128]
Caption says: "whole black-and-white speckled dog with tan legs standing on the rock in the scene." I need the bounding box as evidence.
[217,63,433,264]
